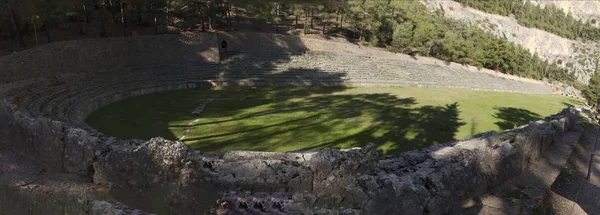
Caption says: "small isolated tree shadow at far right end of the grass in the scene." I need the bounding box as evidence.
[494,107,542,130]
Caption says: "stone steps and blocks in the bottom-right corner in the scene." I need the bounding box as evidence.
[455,128,600,215]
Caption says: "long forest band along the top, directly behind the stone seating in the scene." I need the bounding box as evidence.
[0,0,574,83]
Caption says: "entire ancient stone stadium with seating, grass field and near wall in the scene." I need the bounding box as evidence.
[0,33,592,214]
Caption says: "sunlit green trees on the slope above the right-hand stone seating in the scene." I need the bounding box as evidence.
[349,1,574,82]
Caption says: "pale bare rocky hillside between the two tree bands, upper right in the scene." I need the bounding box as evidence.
[422,0,600,84]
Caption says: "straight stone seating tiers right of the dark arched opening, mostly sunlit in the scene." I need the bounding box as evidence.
[221,50,552,93]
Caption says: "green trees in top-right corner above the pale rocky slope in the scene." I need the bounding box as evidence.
[456,0,600,40]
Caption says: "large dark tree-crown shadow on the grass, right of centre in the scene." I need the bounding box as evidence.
[306,98,465,154]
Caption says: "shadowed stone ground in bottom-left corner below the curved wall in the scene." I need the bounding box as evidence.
[0,150,147,215]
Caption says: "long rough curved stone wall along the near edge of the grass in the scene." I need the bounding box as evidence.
[0,90,578,214]
